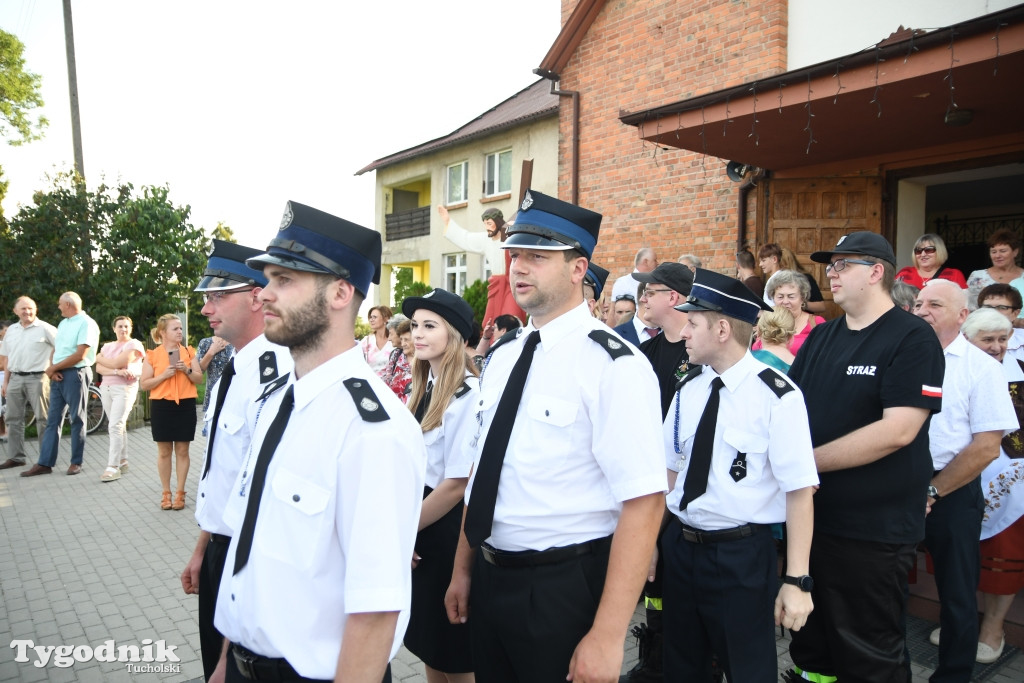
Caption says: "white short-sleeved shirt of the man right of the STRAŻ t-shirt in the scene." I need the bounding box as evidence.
[928,335,1018,470]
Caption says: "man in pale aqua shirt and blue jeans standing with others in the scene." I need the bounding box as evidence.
[22,292,99,477]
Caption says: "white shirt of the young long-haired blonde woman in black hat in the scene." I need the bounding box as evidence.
[423,374,480,488]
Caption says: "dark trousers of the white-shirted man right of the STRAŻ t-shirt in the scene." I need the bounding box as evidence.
[925,477,985,683]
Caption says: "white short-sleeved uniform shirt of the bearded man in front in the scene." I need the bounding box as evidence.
[214,347,426,679]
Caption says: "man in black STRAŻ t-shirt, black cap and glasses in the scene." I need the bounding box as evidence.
[790,232,945,683]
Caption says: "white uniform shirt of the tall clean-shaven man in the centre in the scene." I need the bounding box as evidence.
[466,303,668,551]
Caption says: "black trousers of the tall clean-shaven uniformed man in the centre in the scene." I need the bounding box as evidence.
[469,547,608,683]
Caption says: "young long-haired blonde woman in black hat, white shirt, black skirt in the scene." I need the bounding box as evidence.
[401,289,477,683]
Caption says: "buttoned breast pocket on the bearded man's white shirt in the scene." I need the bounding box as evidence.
[255,470,331,569]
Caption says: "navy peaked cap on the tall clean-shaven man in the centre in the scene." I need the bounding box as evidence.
[502,189,601,259]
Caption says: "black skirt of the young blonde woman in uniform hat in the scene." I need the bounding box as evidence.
[406,486,473,674]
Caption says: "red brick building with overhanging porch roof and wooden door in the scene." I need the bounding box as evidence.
[537,0,1024,313]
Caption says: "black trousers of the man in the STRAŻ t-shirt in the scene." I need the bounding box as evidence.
[790,531,916,683]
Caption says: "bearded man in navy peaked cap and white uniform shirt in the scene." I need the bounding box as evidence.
[214,202,426,683]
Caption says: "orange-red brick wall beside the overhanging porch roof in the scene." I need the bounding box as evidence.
[559,0,787,278]
